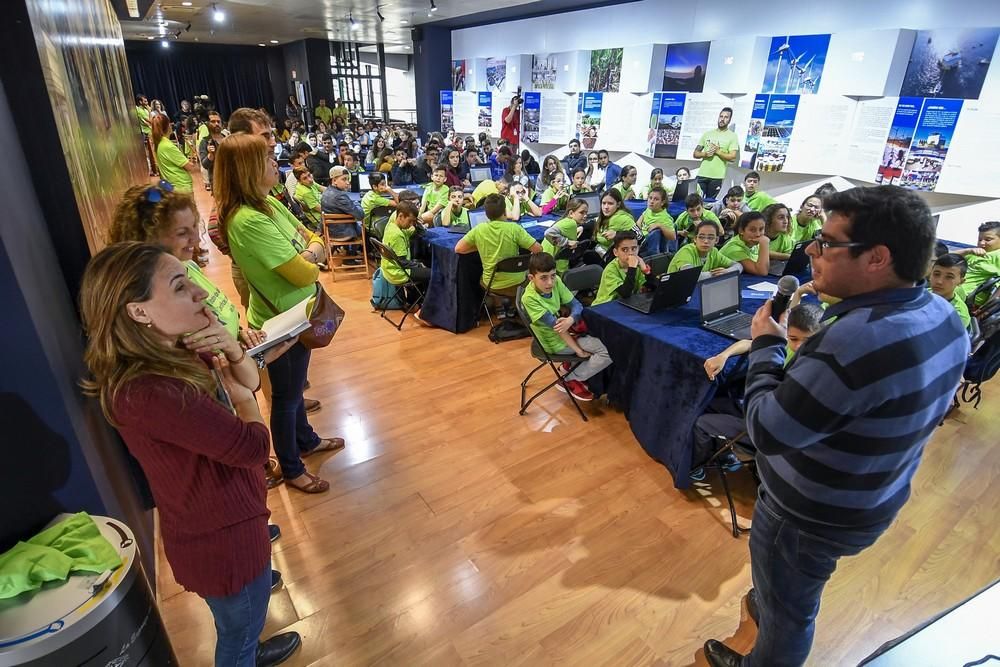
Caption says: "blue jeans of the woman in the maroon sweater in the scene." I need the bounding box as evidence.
[205,563,271,667]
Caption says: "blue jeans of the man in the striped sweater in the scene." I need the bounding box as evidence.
[743,486,881,667]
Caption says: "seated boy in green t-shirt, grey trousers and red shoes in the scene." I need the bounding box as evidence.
[520,253,611,401]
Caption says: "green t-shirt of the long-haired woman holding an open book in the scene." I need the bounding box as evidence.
[229,197,316,328]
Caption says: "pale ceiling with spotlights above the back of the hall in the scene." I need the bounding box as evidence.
[122,0,548,53]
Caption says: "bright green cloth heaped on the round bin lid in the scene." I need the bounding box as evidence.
[0,512,122,600]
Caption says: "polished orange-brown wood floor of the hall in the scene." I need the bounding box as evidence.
[158,180,1000,667]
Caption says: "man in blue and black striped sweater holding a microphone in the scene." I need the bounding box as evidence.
[705,185,969,667]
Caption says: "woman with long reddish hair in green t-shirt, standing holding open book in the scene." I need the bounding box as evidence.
[213,133,344,493]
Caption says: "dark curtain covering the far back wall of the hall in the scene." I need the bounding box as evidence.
[125,41,284,117]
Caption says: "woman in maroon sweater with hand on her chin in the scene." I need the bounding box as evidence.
[80,242,301,667]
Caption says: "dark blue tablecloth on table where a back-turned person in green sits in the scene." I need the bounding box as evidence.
[420,216,556,333]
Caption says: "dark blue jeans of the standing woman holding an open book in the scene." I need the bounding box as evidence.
[267,343,320,479]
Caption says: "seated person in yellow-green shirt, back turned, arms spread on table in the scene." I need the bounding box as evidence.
[455,194,542,297]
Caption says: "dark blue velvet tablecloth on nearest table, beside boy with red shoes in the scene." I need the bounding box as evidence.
[583,276,776,489]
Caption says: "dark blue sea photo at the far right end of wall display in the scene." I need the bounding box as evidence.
[900,28,1000,100]
